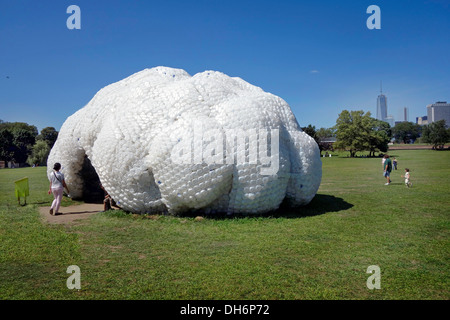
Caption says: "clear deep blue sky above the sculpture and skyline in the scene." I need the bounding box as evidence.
[0,0,450,130]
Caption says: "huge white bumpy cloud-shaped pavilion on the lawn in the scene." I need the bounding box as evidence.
[48,67,322,214]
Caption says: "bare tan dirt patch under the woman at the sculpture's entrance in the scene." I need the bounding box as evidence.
[39,203,103,224]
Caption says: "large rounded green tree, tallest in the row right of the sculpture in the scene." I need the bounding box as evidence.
[334,110,373,157]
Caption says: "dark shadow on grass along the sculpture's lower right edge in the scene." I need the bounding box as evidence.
[187,194,353,219]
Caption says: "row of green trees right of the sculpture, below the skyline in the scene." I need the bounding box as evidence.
[302,110,450,157]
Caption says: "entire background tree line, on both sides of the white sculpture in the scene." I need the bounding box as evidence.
[0,110,450,165]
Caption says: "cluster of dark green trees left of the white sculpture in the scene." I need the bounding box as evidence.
[0,120,58,166]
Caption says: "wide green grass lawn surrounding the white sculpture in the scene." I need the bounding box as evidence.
[0,150,450,300]
